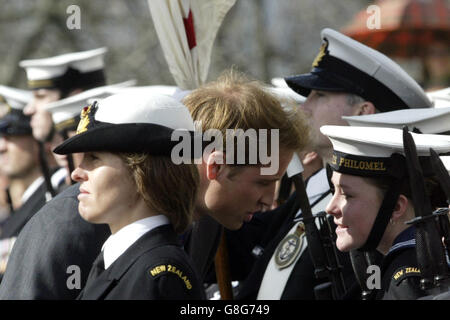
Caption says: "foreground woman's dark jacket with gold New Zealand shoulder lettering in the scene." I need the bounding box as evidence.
[77,225,205,300]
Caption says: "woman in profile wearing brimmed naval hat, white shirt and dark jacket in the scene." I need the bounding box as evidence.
[54,92,204,300]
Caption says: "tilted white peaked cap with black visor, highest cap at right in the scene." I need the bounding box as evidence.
[285,28,432,111]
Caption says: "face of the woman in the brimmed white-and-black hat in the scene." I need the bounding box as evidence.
[72,152,138,226]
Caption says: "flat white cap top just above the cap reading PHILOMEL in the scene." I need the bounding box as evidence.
[342,106,450,134]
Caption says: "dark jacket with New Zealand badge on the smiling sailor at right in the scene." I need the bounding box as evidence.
[376,227,427,300]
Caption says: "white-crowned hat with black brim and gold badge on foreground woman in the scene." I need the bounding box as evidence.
[54,91,194,156]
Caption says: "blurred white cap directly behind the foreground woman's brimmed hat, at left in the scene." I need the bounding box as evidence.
[45,80,136,131]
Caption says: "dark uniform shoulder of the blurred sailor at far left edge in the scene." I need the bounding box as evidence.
[0,182,47,239]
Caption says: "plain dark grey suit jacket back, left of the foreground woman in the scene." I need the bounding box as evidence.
[0,183,111,300]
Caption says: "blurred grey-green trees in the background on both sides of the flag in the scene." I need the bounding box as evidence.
[0,0,442,88]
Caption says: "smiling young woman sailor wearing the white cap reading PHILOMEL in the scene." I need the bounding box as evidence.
[320,126,450,300]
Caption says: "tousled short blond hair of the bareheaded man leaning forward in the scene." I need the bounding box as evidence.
[183,70,309,165]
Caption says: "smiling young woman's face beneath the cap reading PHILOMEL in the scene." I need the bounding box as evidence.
[326,172,382,251]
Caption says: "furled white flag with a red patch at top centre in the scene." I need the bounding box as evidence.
[148,0,236,90]
